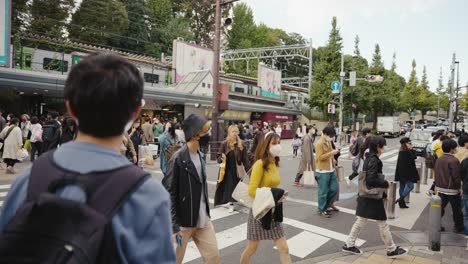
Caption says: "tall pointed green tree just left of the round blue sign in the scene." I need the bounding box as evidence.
[309,17,343,111]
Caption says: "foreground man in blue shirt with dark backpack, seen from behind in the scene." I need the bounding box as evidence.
[0,54,175,264]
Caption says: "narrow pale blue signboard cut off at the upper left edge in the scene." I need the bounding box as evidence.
[0,0,11,67]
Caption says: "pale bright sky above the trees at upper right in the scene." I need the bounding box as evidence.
[241,0,468,90]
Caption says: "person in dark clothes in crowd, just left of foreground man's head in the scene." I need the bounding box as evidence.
[42,112,62,153]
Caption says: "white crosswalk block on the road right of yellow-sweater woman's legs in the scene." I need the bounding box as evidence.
[288,231,330,259]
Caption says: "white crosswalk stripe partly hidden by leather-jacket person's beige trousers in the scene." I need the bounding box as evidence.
[183,223,247,263]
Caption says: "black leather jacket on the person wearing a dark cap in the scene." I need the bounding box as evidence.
[162,145,210,233]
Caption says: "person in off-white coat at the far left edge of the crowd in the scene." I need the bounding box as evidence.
[0,118,23,174]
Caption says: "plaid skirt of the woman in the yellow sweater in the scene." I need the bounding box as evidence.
[247,210,284,240]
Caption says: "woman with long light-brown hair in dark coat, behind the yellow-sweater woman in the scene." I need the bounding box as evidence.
[214,125,250,212]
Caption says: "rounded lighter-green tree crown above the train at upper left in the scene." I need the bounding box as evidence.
[68,0,128,46]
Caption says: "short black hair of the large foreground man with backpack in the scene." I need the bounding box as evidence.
[64,54,144,138]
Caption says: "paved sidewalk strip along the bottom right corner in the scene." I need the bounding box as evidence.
[295,244,468,264]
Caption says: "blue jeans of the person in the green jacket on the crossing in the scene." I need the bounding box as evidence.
[315,171,338,213]
